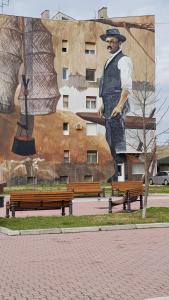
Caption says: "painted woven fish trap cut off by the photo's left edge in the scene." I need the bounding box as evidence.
[0,15,22,113]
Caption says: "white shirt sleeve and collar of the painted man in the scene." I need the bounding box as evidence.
[105,49,133,93]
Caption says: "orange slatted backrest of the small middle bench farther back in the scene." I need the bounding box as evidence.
[67,182,102,191]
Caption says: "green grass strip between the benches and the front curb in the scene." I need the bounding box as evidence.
[0,207,169,230]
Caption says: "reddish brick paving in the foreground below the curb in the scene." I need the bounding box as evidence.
[0,228,169,300]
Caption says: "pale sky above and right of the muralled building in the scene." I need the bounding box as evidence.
[0,0,169,143]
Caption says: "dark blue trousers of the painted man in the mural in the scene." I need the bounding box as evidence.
[102,92,129,181]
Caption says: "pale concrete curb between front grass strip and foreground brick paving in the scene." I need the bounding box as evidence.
[0,223,169,236]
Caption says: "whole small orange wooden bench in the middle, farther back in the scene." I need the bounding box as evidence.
[67,182,105,197]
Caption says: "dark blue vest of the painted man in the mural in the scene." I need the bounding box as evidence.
[99,51,125,97]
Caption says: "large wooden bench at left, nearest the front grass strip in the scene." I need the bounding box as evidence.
[6,191,73,218]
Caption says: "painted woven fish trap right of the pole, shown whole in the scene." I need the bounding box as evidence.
[19,18,60,115]
